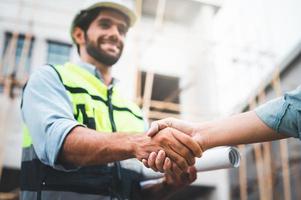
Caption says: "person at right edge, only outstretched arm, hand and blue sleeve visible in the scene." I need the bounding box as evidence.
[143,86,301,172]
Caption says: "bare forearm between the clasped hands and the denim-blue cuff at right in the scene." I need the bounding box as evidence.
[196,111,287,150]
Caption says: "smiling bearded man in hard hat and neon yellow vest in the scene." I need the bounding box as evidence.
[21,0,201,200]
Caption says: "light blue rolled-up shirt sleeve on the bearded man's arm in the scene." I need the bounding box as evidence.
[21,66,81,170]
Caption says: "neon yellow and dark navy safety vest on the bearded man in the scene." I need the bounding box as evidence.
[21,63,145,200]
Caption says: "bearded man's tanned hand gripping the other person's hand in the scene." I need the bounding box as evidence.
[135,128,202,172]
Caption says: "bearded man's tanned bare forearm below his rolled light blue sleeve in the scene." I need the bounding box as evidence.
[59,126,141,166]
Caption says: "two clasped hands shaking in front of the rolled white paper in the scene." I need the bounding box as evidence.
[131,118,205,184]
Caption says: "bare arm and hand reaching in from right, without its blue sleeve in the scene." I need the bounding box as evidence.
[143,111,289,171]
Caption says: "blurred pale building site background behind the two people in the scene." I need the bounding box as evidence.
[0,0,301,200]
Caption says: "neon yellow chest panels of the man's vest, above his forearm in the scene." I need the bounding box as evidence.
[55,63,144,133]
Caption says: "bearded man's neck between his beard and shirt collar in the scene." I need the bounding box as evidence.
[80,52,112,86]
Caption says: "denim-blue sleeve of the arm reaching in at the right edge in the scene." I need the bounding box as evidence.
[255,86,301,139]
